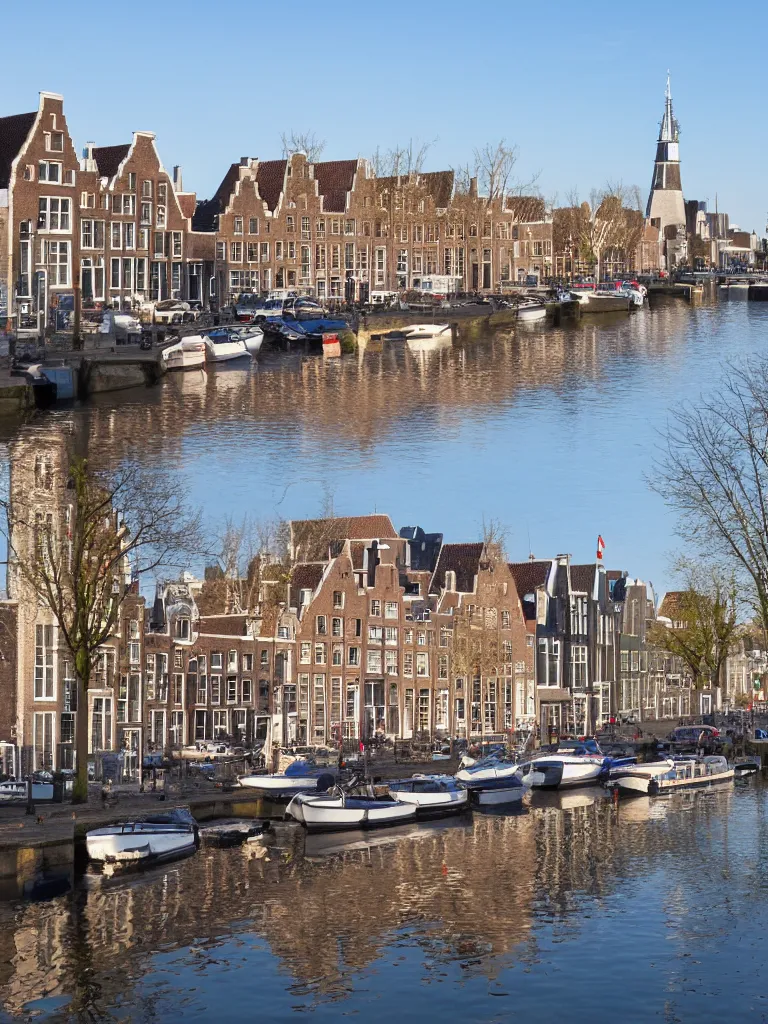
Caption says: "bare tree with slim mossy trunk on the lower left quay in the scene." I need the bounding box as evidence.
[0,458,200,803]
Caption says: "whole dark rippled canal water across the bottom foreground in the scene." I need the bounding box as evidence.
[0,780,768,1024]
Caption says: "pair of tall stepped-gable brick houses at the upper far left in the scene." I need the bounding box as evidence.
[0,92,199,331]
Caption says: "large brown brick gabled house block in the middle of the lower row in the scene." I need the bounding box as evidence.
[291,516,536,742]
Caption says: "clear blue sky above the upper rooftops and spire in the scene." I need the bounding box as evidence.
[6,0,768,233]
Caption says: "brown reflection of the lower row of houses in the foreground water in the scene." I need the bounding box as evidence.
[0,790,733,1016]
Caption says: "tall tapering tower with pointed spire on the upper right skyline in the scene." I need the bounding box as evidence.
[645,75,687,268]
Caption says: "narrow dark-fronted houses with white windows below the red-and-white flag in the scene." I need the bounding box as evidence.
[511,555,624,739]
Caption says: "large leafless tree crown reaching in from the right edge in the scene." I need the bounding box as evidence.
[650,357,768,639]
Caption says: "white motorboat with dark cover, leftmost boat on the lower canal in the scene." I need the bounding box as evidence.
[85,810,197,864]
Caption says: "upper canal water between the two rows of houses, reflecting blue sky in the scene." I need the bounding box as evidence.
[12,292,768,590]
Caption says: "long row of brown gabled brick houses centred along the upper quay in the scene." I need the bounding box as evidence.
[201,154,552,301]
